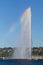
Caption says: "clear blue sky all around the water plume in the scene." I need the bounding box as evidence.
[0,0,43,47]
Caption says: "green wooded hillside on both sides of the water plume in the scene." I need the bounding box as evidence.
[0,47,43,57]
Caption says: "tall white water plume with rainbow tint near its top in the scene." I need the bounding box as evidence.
[12,8,31,59]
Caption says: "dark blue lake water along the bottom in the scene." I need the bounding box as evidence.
[0,60,43,65]
